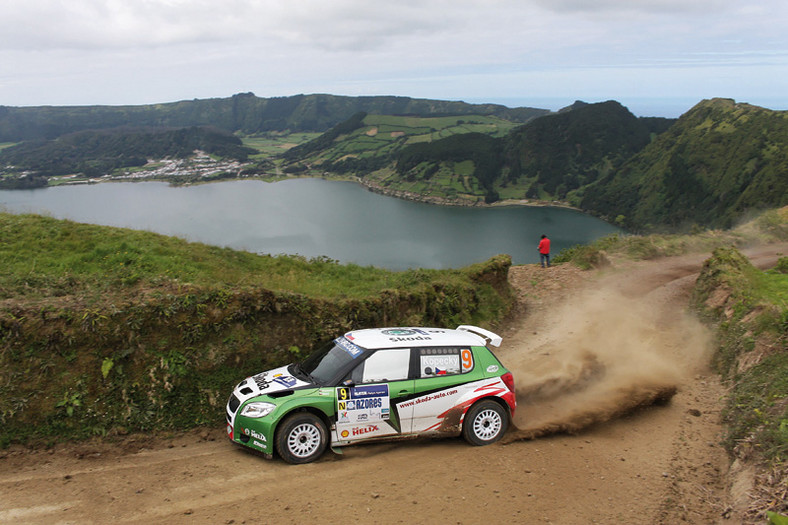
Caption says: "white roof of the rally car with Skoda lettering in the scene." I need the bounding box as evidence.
[345,325,501,350]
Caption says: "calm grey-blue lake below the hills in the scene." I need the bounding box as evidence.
[0,179,620,270]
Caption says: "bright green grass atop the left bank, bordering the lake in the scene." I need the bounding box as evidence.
[0,213,498,299]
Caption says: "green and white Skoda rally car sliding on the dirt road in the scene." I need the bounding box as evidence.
[227,325,516,463]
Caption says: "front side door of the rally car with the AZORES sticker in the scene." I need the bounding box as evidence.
[335,348,414,445]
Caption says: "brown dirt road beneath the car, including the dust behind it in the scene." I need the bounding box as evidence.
[0,245,788,524]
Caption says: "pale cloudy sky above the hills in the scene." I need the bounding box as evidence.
[0,0,788,116]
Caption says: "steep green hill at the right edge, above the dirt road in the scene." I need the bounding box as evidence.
[581,99,788,229]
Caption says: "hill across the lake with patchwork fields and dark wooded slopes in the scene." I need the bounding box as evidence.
[298,101,673,208]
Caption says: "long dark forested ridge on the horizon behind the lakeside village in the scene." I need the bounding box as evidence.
[0,93,550,143]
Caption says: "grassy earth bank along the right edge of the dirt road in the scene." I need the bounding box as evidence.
[693,227,788,523]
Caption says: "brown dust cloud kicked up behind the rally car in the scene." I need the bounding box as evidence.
[505,283,711,442]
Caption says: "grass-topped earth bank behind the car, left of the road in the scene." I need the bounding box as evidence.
[0,214,511,446]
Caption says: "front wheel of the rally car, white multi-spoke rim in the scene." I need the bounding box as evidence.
[276,412,328,465]
